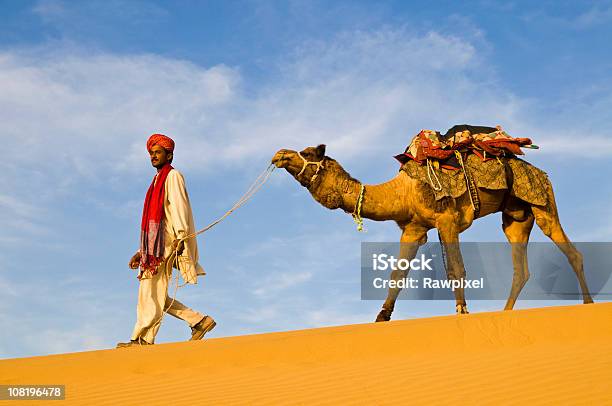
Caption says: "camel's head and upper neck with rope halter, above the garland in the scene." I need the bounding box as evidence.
[272,144,354,210]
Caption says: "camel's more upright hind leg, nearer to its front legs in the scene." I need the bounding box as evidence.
[502,212,534,310]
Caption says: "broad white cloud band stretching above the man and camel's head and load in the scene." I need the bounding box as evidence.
[0,25,609,195]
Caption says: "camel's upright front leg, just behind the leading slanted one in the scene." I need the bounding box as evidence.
[438,219,469,314]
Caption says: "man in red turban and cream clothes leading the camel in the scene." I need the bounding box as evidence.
[117,134,216,348]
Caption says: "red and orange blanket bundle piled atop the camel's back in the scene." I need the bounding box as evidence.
[395,124,532,169]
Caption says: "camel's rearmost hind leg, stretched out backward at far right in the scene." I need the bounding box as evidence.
[531,183,593,303]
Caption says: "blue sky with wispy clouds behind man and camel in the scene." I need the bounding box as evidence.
[0,0,612,358]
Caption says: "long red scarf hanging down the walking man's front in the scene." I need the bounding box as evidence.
[138,163,173,279]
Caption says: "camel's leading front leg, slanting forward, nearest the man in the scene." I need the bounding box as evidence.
[376,224,427,322]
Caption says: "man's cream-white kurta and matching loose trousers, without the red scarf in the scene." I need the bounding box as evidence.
[132,169,204,344]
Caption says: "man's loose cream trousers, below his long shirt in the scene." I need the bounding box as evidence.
[132,270,204,344]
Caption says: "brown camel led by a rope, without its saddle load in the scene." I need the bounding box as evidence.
[272,145,593,322]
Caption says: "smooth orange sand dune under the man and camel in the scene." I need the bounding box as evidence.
[0,303,612,405]
